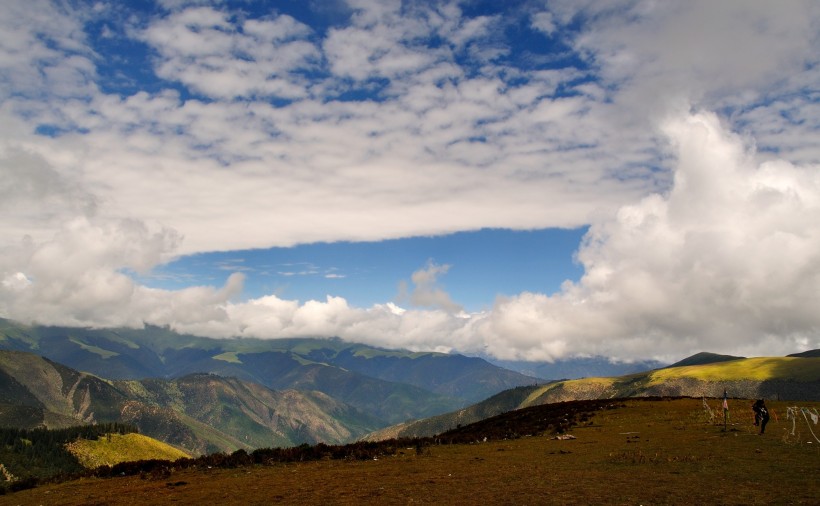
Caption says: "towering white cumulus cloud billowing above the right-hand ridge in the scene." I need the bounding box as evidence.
[464,113,820,359]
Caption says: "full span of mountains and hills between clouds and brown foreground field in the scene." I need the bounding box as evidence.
[0,319,820,455]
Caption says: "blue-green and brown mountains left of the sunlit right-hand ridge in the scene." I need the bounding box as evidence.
[0,319,543,454]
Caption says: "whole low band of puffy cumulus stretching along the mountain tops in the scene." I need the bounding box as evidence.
[0,113,820,360]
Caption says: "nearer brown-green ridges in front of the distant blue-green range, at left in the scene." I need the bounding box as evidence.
[0,351,381,454]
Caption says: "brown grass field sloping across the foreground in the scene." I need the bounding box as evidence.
[0,399,820,505]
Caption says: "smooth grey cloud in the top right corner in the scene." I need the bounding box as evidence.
[546,0,820,161]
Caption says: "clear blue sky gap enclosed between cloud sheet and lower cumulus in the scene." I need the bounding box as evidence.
[143,228,585,311]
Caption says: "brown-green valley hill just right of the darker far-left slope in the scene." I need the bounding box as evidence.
[114,374,378,453]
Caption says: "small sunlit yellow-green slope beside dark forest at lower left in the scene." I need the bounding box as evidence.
[66,433,190,469]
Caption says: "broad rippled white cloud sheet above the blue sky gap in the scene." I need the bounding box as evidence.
[0,0,654,253]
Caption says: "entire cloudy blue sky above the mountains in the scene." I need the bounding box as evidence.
[0,0,820,362]
